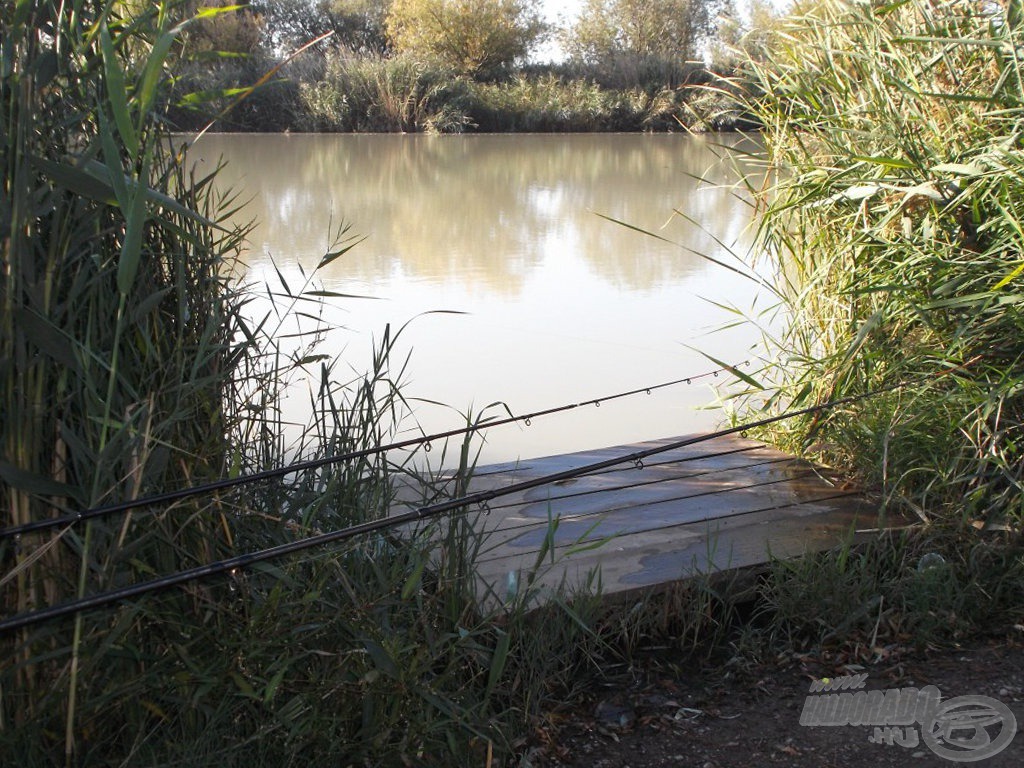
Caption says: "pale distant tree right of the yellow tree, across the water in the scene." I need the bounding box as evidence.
[563,0,725,63]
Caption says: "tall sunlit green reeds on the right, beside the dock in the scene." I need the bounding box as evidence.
[729,0,1024,525]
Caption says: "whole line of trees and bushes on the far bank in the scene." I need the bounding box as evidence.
[170,0,770,131]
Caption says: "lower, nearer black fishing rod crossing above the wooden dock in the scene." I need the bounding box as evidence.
[0,367,950,633]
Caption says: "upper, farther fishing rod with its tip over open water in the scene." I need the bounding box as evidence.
[0,360,751,539]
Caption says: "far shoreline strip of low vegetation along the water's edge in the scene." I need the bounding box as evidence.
[165,65,757,134]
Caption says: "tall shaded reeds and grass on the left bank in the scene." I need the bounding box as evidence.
[0,0,737,766]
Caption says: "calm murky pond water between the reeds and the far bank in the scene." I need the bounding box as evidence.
[193,134,770,463]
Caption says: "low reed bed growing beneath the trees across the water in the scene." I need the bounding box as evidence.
[168,52,702,133]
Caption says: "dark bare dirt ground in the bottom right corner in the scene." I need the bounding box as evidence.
[530,628,1024,768]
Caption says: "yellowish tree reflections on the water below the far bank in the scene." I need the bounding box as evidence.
[194,135,757,293]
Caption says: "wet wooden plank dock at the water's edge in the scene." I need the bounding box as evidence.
[395,436,899,596]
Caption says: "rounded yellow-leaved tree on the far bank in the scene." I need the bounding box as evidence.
[387,0,546,77]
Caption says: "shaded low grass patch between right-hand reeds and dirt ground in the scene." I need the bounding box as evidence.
[748,528,1024,662]
